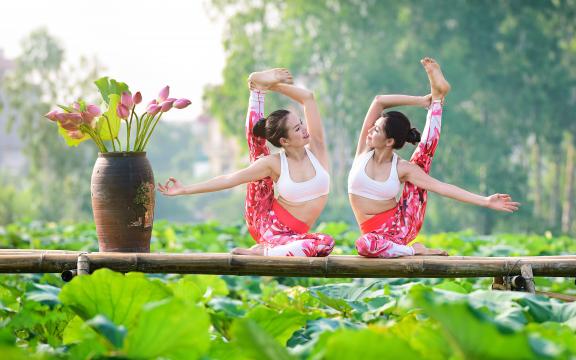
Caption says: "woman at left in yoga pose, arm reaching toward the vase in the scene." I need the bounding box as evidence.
[158,69,334,257]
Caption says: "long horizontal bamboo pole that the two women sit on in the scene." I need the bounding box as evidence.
[0,250,576,278]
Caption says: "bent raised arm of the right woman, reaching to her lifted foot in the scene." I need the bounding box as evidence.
[356,95,432,156]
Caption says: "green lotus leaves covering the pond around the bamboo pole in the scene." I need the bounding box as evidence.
[0,223,576,360]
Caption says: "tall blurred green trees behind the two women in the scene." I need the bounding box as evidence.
[205,0,576,234]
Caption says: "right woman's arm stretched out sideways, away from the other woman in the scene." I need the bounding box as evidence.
[403,163,520,212]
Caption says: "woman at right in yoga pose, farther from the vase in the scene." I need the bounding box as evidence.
[348,58,520,258]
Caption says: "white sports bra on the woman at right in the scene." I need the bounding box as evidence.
[348,150,401,200]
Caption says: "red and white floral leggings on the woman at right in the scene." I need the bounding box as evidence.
[356,101,442,258]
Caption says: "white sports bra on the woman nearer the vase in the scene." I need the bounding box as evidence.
[276,148,330,202]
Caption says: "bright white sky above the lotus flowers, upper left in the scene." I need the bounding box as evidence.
[0,0,224,120]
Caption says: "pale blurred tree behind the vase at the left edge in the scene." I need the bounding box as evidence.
[1,29,99,221]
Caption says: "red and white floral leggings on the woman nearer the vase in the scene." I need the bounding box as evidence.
[245,91,334,257]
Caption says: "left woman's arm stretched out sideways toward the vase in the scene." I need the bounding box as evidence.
[158,158,273,196]
